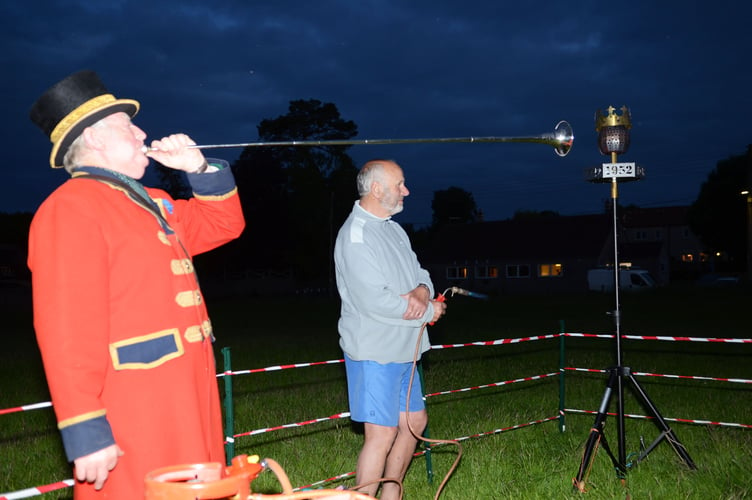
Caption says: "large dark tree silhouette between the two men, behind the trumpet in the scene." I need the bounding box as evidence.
[226,99,357,287]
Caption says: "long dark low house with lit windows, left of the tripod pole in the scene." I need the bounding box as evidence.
[420,215,611,294]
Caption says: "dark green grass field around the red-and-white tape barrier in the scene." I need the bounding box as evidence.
[0,287,752,500]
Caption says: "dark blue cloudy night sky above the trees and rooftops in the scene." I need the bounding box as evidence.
[0,0,752,224]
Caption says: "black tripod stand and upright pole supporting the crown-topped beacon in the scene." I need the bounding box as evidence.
[573,176,697,492]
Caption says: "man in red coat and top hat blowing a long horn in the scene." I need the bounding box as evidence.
[28,71,245,500]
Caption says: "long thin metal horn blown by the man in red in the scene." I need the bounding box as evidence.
[143,120,574,156]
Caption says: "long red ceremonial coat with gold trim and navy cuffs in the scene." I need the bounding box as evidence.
[28,168,245,500]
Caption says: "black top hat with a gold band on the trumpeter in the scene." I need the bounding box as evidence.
[29,70,140,168]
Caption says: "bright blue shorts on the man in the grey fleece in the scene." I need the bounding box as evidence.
[345,355,426,427]
